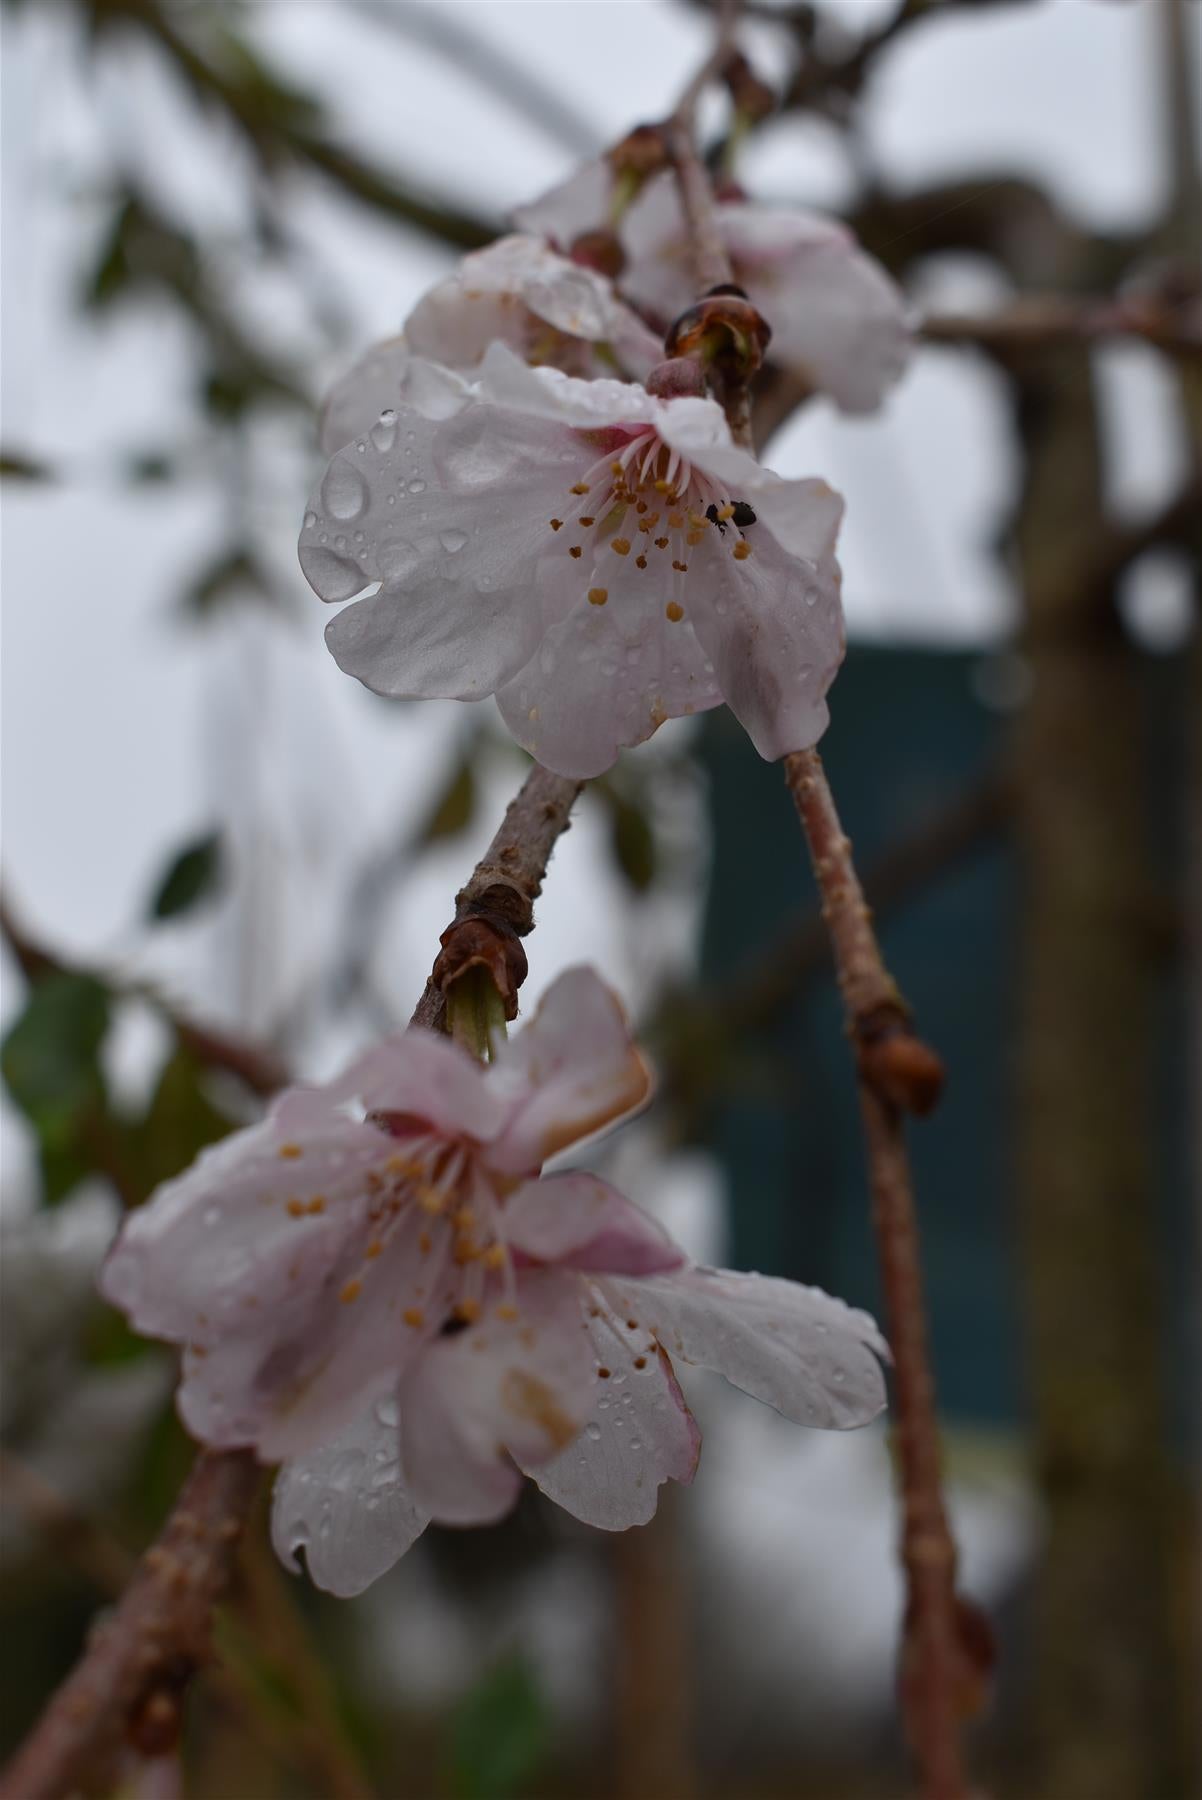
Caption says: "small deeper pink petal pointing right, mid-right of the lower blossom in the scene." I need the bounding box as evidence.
[504,1170,684,1274]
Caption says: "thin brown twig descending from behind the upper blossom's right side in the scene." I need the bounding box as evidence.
[669,21,966,1800]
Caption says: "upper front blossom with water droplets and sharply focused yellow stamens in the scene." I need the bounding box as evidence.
[301,344,844,778]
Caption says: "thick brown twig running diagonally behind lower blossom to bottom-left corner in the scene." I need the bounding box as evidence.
[0,765,581,1800]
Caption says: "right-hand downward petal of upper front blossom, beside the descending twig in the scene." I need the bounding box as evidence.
[689,524,844,761]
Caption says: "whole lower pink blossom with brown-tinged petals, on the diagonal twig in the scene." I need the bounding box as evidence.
[101,968,885,1593]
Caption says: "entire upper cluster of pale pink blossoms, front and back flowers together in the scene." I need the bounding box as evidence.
[301,164,907,778]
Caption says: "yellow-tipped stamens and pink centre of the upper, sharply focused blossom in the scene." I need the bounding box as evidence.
[549,427,756,623]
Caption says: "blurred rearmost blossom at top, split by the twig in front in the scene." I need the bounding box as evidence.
[516,173,910,412]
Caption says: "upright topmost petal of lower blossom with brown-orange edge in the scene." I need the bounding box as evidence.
[488,968,651,1172]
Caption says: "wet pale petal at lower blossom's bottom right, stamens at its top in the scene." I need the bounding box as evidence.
[527,1316,702,1532]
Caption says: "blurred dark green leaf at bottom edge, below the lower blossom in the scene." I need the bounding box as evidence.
[450,1658,551,1800]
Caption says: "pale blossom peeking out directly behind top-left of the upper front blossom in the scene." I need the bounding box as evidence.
[320,236,664,455]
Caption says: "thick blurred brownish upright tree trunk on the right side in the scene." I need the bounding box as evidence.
[1017,353,1186,1800]
